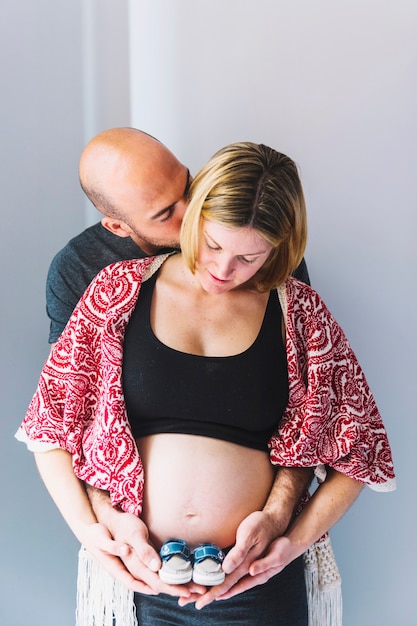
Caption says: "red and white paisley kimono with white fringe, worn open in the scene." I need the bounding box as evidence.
[16,255,395,626]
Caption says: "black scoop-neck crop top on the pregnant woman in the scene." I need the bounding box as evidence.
[122,274,288,451]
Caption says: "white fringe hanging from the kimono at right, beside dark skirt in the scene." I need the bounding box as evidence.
[304,536,342,626]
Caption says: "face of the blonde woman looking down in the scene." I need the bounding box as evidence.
[195,220,272,295]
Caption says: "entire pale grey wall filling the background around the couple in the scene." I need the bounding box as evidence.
[0,0,417,626]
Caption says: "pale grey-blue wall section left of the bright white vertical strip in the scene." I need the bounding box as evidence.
[0,0,130,626]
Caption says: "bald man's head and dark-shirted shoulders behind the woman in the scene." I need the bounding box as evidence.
[46,128,310,343]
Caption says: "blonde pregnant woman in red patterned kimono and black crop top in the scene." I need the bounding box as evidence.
[18,143,394,626]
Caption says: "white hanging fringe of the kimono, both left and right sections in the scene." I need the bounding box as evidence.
[76,536,342,626]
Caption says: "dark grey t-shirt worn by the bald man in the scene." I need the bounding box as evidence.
[46,222,310,343]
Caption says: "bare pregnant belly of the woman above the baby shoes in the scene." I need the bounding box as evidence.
[137,433,275,548]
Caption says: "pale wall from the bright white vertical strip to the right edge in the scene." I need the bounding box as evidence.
[130,0,417,626]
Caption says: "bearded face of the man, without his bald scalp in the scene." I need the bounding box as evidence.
[117,162,191,254]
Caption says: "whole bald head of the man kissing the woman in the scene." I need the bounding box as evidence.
[79,128,189,254]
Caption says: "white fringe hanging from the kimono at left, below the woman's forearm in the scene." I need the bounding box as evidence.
[76,547,138,626]
